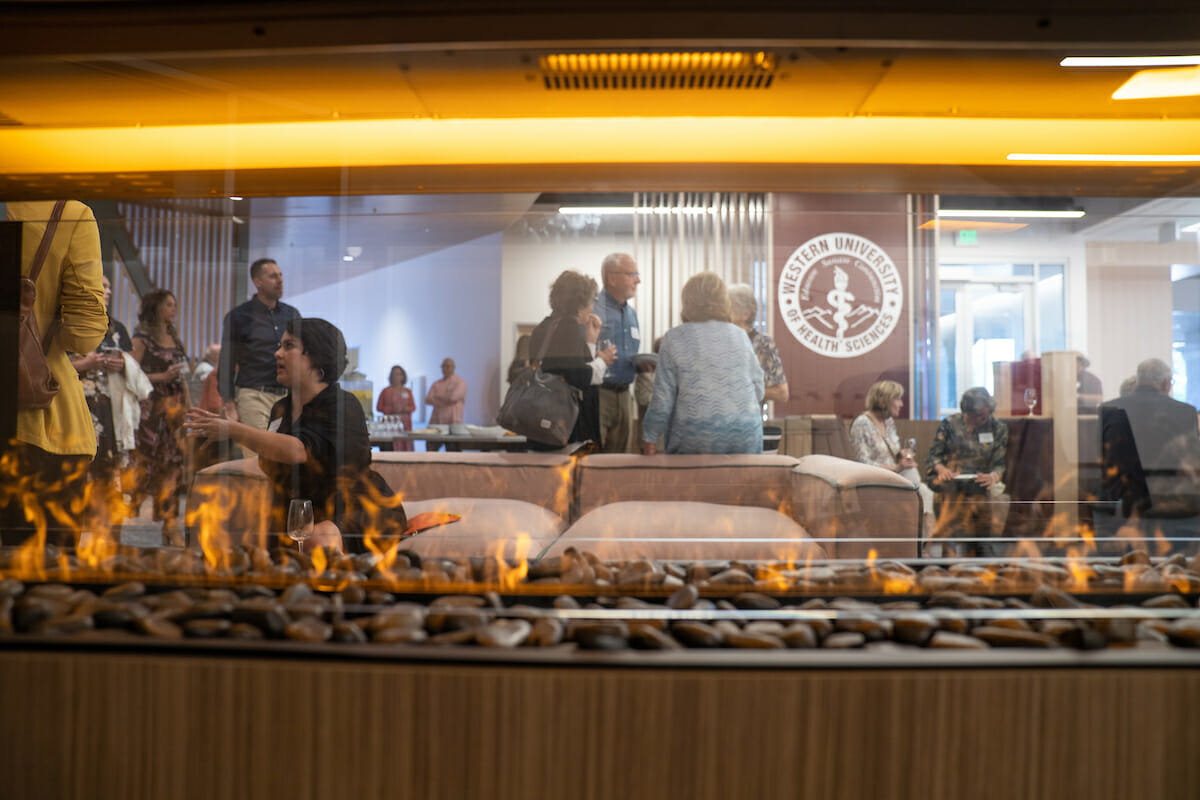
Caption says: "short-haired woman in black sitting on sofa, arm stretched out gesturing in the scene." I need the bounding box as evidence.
[187,318,408,553]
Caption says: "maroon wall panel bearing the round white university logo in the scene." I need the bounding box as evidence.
[773,193,912,417]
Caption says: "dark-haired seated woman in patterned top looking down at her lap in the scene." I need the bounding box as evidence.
[925,386,1008,555]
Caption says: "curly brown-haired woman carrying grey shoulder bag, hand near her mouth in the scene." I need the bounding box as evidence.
[529,270,617,450]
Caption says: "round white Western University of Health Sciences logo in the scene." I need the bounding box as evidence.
[779,234,904,359]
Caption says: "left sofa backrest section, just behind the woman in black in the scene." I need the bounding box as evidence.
[371,452,572,519]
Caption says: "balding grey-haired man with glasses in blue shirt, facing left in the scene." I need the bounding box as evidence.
[593,253,642,453]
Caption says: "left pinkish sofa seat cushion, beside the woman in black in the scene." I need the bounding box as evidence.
[401,498,566,559]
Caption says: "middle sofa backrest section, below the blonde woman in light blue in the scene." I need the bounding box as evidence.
[576,453,797,516]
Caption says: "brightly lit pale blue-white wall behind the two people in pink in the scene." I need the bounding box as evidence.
[284,234,504,425]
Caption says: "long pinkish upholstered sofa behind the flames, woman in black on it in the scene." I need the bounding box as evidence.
[187,452,920,561]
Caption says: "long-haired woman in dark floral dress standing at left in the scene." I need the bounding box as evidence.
[133,289,191,546]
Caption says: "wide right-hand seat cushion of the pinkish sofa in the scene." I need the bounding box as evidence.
[545,501,824,561]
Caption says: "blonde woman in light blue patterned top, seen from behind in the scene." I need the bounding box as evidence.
[642,272,763,456]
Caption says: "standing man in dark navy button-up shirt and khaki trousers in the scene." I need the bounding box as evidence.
[217,258,302,431]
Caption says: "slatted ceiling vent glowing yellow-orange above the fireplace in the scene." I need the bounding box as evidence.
[539,52,775,91]
